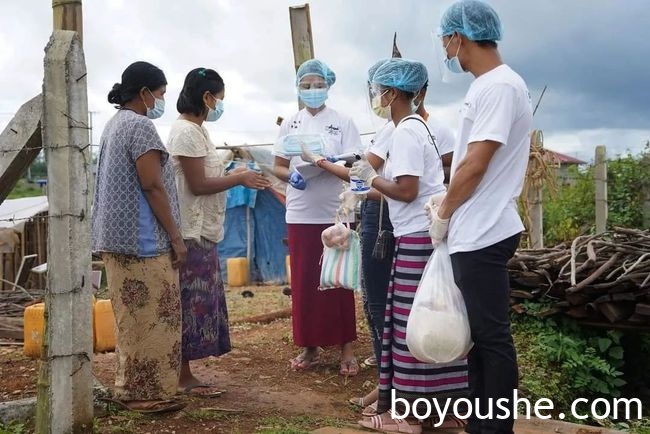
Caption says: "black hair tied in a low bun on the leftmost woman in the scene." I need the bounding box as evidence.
[108,61,167,108]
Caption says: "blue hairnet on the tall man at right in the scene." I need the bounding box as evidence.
[438,0,502,41]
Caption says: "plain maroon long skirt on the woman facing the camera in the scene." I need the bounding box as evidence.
[287,224,357,347]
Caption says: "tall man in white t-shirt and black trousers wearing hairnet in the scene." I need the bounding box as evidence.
[430,0,532,434]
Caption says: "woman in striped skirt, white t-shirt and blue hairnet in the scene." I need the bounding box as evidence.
[350,59,468,434]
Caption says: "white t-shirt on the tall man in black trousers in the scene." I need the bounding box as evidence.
[448,65,533,253]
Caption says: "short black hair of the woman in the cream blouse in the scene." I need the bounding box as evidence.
[176,68,224,116]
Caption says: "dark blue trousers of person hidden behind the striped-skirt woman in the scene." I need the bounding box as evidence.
[361,200,394,366]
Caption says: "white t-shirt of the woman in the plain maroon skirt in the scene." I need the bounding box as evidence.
[273,107,363,224]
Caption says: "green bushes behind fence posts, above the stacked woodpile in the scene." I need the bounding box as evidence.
[544,144,650,246]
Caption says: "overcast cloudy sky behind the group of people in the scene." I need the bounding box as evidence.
[0,0,650,160]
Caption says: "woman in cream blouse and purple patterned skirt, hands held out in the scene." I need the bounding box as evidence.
[167,68,270,395]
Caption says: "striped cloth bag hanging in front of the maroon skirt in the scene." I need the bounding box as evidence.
[319,230,361,291]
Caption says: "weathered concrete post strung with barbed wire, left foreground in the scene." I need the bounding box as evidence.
[36,30,93,434]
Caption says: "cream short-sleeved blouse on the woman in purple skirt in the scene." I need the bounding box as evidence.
[167,119,226,243]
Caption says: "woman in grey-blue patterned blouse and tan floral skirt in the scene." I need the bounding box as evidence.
[92,62,187,413]
